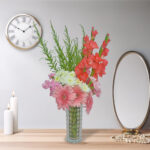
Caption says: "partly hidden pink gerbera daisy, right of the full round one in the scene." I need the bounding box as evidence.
[72,86,87,107]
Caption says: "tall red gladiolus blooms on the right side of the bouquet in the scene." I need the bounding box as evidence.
[75,27,110,85]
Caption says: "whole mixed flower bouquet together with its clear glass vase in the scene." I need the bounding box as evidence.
[35,24,110,143]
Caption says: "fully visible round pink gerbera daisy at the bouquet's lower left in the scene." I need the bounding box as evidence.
[54,86,76,109]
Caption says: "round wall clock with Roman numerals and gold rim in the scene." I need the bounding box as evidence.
[6,14,42,49]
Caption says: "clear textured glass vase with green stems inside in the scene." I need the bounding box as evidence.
[66,106,82,143]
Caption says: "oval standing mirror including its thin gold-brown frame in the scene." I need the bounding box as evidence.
[113,51,150,131]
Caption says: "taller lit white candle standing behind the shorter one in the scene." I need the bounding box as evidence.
[10,91,18,133]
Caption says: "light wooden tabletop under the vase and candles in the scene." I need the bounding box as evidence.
[0,129,150,150]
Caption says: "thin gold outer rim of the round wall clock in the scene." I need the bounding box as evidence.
[5,13,43,50]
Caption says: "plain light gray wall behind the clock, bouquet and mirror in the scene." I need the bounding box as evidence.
[0,0,150,128]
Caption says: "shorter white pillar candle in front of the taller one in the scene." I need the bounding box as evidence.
[4,106,13,135]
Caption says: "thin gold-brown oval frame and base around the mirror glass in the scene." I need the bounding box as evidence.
[112,51,150,134]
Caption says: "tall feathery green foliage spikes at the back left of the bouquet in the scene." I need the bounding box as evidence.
[34,23,85,71]
